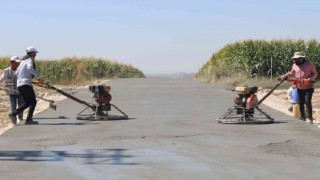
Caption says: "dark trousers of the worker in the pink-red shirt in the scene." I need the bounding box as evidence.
[298,88,314,120]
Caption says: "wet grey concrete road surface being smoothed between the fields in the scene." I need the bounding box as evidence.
[0,78,320,179]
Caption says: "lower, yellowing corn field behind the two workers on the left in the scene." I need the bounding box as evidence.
[0,57,145,84]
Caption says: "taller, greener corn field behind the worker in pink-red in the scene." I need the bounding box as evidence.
[197,39,320,80]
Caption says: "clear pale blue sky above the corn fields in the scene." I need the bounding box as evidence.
[0,0,320,74]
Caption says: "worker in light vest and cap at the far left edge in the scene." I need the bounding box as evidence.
[0,56,24,121]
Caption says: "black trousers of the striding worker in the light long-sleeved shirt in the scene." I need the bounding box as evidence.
[12,85,37,121]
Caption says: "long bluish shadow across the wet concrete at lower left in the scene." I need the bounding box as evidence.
[0,149,139,165]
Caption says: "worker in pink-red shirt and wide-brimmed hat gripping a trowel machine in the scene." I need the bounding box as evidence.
[282,52,318,124]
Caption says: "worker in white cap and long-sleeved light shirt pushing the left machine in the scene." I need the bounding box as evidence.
[9,47,40,125]
